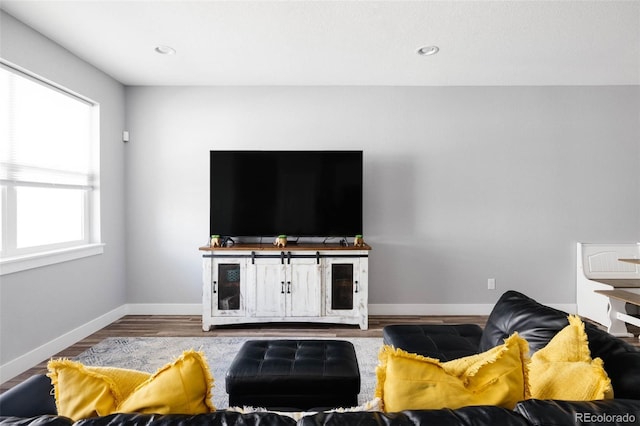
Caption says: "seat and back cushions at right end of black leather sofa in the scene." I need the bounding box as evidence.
[383,291,640,404]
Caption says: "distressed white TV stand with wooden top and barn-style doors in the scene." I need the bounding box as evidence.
[200,242,371,331]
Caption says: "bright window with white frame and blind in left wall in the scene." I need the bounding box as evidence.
[0,63,102,274]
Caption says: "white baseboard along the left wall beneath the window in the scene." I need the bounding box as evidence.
[0,305,127,383]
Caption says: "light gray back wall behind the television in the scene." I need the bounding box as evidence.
[126,87,640,304]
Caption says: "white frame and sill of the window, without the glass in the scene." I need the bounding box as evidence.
[0,58,104,276]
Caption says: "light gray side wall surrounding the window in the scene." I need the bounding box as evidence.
[0,12,126,365]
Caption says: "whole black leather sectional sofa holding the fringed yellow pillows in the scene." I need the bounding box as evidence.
[0,291,640,426]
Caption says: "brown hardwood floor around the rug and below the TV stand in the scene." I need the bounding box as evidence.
[0,315,640,393]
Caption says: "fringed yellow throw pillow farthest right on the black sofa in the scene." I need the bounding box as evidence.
[529,315,613,401]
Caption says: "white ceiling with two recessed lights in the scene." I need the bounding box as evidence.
[0,0,640,86]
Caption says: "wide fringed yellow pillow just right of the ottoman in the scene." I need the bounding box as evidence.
[375,333,529,412]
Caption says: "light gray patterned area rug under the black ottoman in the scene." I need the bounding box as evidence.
[74,337,382,408]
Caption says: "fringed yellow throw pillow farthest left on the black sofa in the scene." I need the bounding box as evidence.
[47,359,151,421]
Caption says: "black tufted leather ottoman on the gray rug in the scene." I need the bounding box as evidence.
[226,340,360,410]
